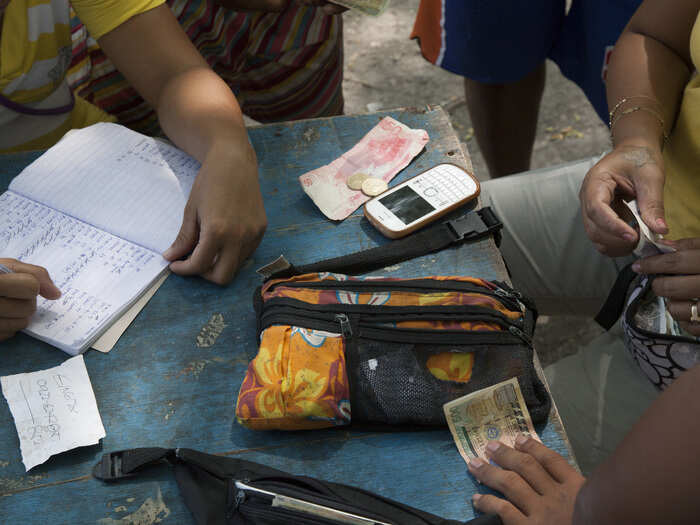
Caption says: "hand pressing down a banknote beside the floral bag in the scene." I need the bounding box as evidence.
[469,435,586,525]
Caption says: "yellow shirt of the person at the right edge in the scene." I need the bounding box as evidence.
[664,15,700,239]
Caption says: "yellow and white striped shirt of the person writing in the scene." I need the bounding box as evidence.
[0,0,164,152]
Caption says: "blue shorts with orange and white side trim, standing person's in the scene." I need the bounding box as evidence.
[411,0,642,121]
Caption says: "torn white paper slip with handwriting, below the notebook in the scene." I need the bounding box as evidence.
[0,355,105,471]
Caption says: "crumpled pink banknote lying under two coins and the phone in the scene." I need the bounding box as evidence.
[299,117,429,221]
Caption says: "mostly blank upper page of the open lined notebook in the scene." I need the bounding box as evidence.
[10,123,200,253]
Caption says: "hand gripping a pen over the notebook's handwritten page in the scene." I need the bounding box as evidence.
[0,259,61,341]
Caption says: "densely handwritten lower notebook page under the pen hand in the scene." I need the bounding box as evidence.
[0,191,167,355]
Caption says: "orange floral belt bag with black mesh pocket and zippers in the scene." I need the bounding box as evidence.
[236,207,550,430]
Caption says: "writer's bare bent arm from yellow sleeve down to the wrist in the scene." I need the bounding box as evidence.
[98,5,255,170]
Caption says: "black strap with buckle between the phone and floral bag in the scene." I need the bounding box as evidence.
[258,206,503,278]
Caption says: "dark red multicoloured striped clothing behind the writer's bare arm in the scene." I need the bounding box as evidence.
[68,0,343,135]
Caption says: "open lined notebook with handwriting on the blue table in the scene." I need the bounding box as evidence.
[0,123,199,355]
